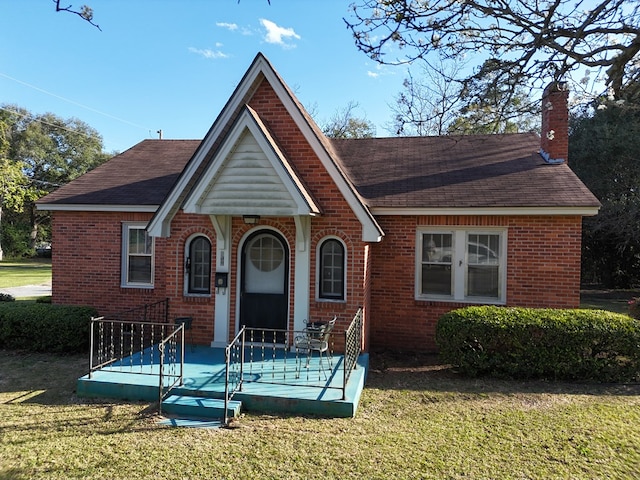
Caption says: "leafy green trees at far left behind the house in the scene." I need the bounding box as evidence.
[0,104,110,259]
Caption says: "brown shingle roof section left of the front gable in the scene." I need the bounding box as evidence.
[38,140,200,205]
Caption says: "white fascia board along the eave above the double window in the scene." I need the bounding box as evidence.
[371,207,599,217]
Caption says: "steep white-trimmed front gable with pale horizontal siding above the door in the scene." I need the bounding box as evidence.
[147,54,384,242]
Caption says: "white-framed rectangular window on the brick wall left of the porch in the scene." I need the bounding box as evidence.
[121,223,153,288]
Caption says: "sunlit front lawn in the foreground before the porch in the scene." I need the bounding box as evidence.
[0,350,640,480]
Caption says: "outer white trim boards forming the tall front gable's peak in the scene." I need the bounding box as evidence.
[147,53,384,242]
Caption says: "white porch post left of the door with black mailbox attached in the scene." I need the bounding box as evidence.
[209,215,231,348]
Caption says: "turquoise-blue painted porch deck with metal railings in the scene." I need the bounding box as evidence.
[77,346,369,417]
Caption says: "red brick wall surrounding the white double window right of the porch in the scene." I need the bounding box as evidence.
[370,216,581,351]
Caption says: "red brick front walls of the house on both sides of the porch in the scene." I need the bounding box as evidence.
[48,82,581,350]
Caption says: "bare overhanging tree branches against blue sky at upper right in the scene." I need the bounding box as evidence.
[345,0,640,104]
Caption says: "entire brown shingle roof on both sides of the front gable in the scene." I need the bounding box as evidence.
[39,134,599,210]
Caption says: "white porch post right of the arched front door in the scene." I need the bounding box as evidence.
[293,215,313,330]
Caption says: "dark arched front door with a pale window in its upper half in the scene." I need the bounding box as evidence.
[240,230,289,340]
